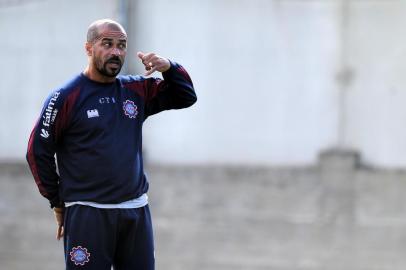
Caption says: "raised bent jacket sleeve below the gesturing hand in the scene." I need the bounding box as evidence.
[145,62,197,117]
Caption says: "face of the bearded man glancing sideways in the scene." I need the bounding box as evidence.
[91,28,127,77]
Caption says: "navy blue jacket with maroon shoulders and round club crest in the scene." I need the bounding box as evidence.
[27,62,197,207]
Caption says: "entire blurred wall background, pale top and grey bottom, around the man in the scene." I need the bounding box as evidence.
[0,0,406,270]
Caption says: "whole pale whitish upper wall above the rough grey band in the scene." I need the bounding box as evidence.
[0,0,406,167]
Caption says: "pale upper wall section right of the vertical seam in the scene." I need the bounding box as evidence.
[345,1,406,167]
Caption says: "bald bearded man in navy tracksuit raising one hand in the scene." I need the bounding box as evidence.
[27,19,196,270]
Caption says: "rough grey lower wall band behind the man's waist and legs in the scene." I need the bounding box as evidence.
[0,152,406,270]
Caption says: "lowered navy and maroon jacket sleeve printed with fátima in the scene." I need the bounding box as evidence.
[26,91,69,207]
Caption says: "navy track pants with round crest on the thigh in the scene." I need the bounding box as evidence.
[64,205,155,270]
